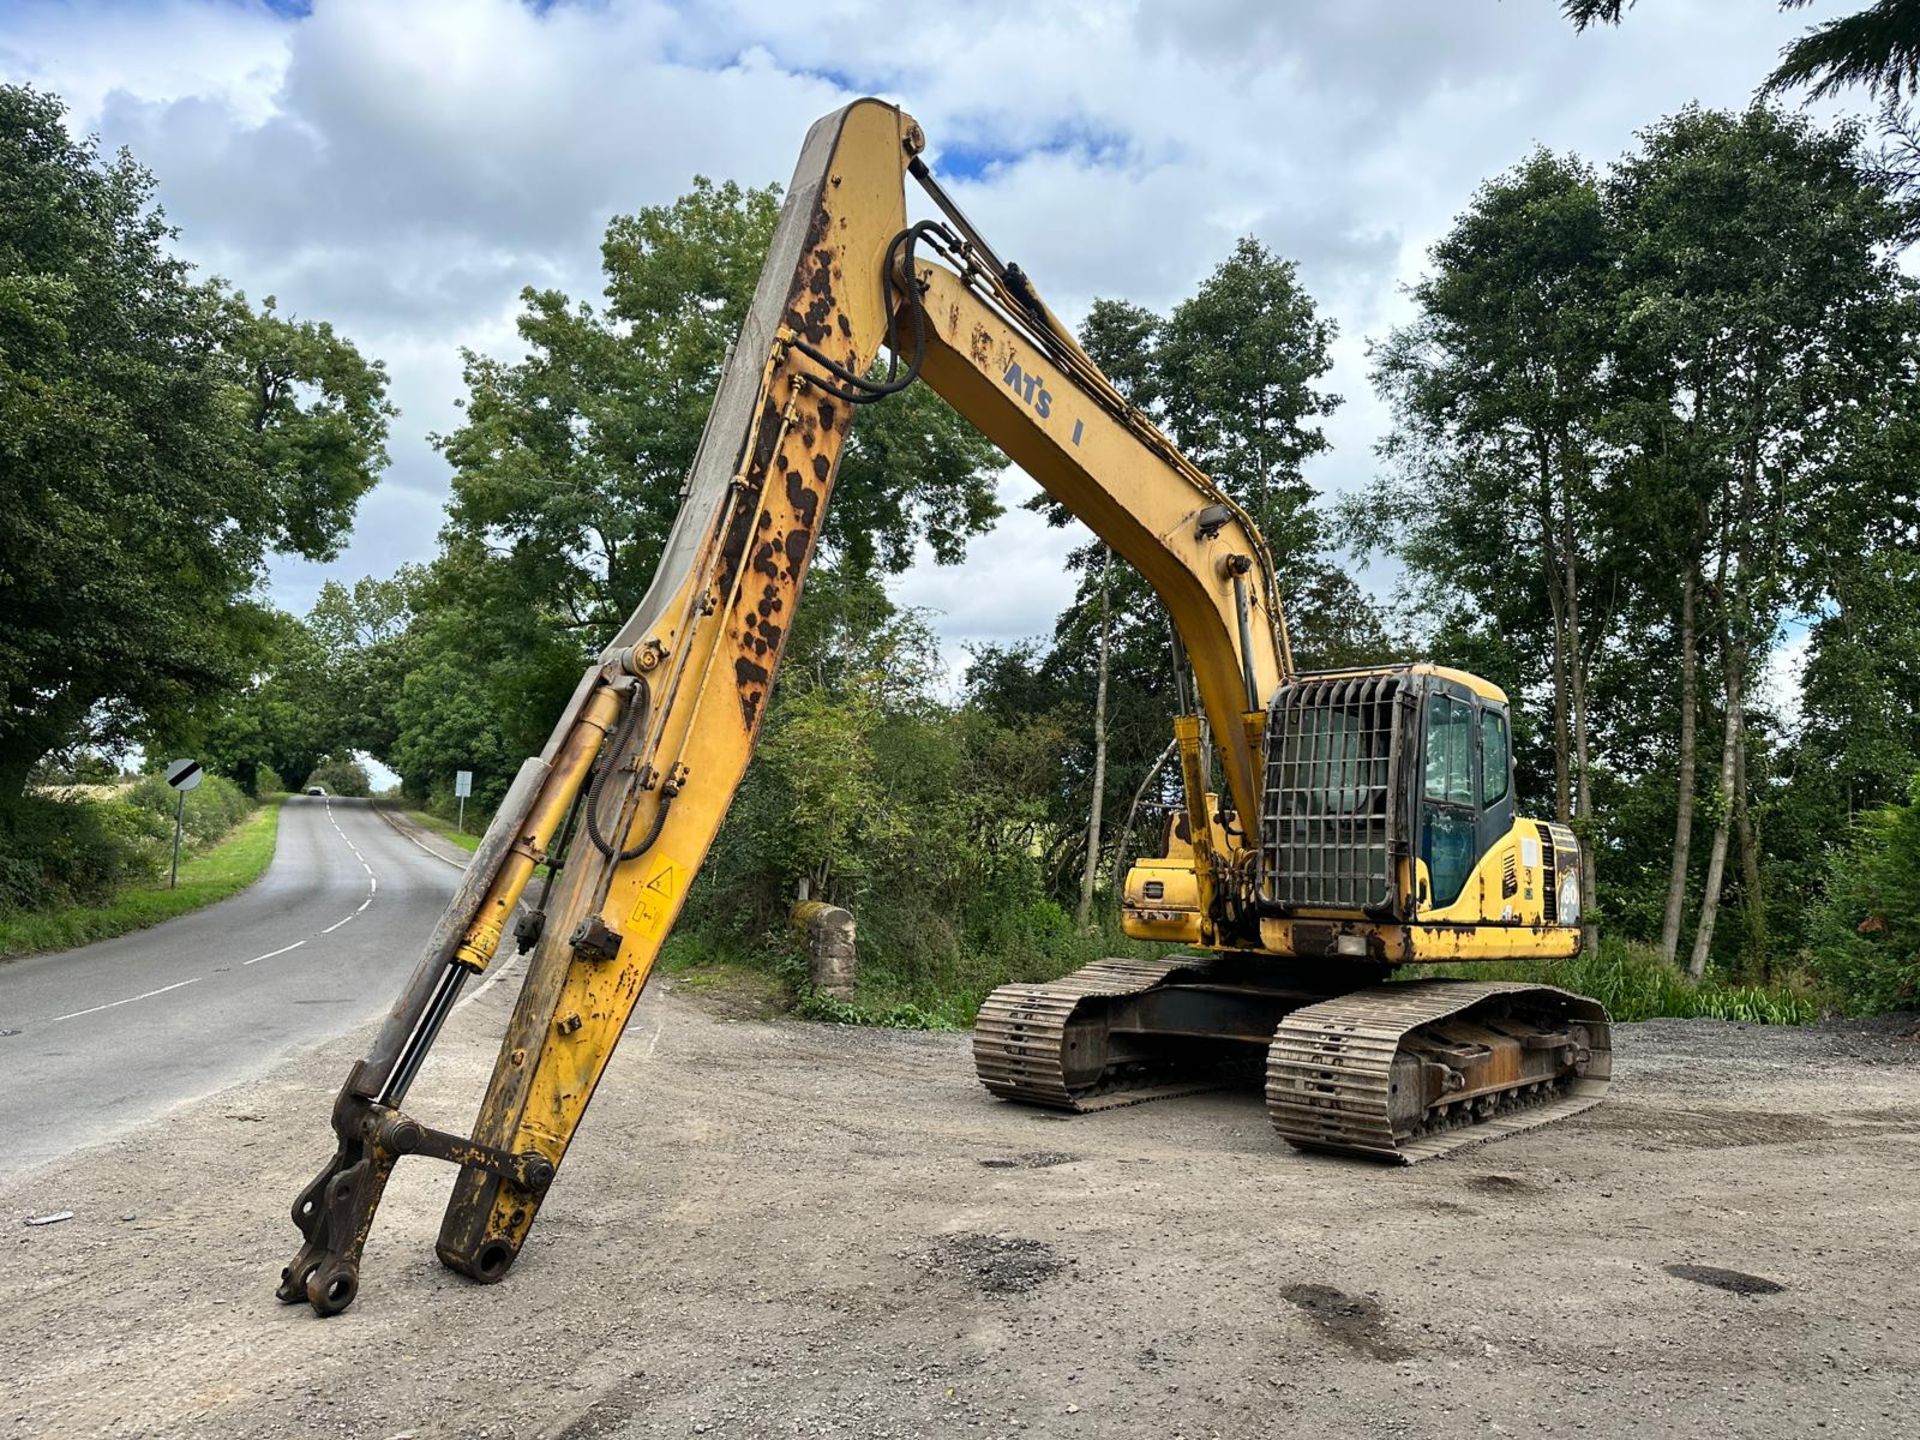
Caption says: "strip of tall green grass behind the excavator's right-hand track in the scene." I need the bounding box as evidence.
[1404,939,1820,1025]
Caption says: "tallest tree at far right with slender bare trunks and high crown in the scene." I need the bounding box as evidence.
[1609,106,1914,975]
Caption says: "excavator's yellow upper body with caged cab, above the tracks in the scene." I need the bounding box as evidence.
[1123,664,1580,964]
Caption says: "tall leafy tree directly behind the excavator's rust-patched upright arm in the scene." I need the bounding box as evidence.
[396,179,1002,814]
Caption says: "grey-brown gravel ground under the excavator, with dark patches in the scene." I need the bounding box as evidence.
[0,985,1920,1440]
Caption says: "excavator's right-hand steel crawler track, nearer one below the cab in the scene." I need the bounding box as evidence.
[1267,979,1613,1164]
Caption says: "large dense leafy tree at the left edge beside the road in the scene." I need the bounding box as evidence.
[0,86,394,808]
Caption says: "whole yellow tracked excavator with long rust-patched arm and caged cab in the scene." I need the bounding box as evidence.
[278,100,1609,1315]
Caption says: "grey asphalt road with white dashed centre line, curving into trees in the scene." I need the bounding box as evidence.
[0,795,459,1179]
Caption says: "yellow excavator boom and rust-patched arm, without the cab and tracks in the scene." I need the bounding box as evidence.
[278,100,1290,1315]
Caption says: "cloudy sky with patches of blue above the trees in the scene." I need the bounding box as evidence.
[0,0,1859,721]
